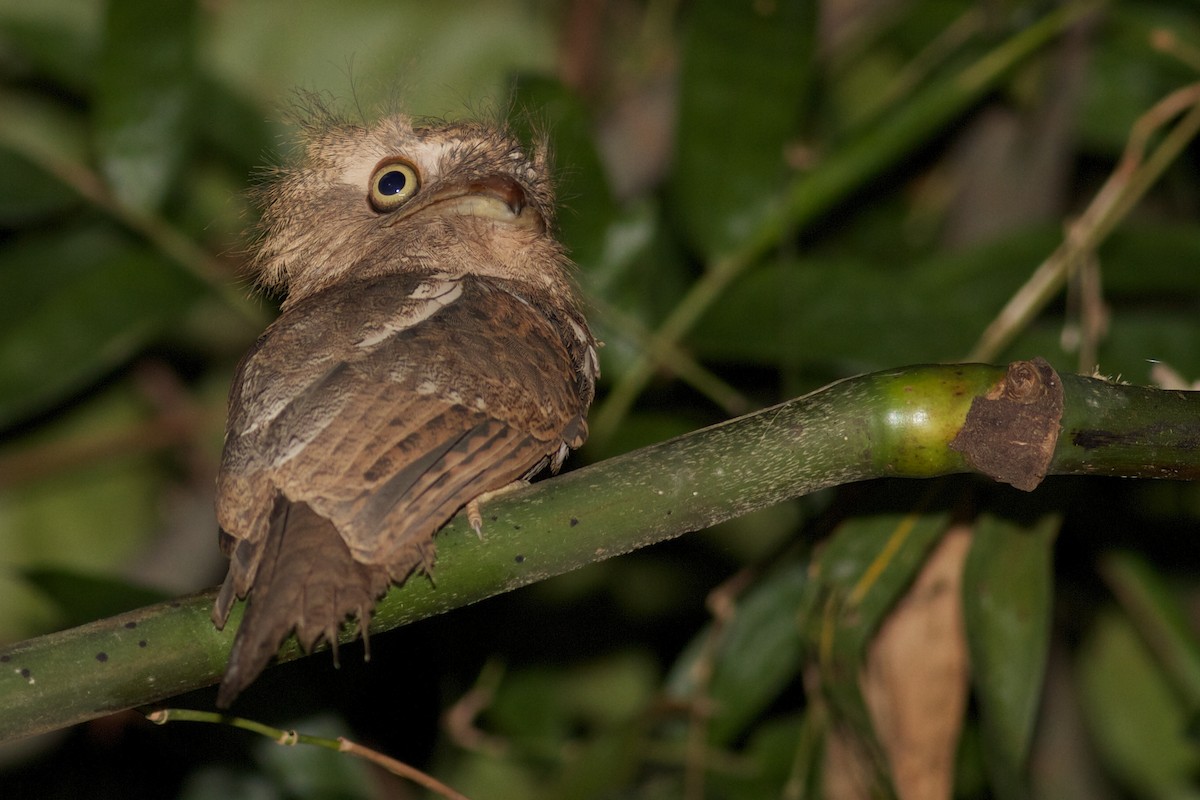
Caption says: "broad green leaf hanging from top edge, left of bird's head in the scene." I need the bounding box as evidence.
[95,0,196,211]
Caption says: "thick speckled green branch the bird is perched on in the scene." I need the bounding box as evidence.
[0,361,1200,741]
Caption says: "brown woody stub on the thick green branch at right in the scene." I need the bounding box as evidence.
[950,357,1063,492]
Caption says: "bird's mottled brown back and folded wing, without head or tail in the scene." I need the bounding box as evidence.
[218,275,594,582]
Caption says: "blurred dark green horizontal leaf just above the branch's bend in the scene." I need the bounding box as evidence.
[689,230,1054,378]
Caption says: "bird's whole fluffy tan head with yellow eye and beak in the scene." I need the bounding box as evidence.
[254,106,569,306]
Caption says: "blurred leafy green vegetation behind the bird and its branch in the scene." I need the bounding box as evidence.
[0,0,1200,800]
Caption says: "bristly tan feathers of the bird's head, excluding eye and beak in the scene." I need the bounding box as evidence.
[244,100,566,302]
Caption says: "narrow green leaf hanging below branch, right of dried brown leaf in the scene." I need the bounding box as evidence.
[962,513,1061,796]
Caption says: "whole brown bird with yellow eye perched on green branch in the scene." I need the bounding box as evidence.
[212,107,600,708]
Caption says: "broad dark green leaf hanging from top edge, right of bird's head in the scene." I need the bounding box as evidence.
[670,0,817,258]
